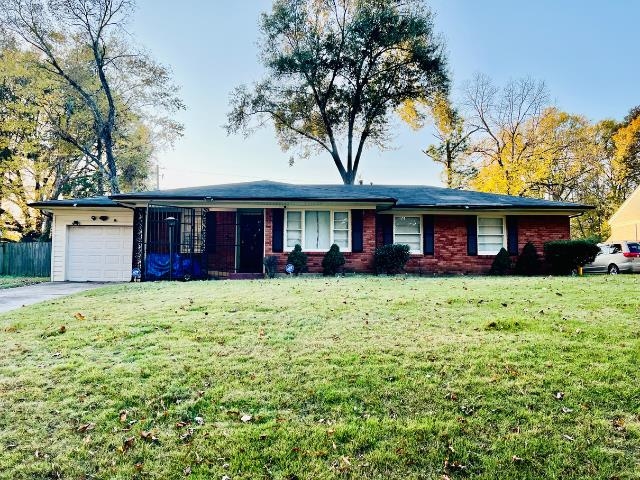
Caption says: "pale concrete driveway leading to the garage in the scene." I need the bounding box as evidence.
[0,282,112,313]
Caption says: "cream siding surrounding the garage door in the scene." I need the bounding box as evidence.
[51,207,133,282]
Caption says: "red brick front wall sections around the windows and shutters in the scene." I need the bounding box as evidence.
[264,209,570,274]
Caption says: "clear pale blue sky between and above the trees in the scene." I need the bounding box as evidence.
[129,0,640,188]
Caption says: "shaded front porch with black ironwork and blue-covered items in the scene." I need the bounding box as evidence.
[133,205,264,281]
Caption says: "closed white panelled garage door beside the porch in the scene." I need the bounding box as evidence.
[66,225,133,282]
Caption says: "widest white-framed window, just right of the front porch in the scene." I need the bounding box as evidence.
[285,210,351,251]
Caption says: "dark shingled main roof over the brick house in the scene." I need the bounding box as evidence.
[111,181,592,210]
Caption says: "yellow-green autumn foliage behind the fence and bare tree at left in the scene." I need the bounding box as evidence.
[0,43,158,240]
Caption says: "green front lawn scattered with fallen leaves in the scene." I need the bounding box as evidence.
[0,276,640,480]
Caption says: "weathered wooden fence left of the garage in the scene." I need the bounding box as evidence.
[0,242,51,277]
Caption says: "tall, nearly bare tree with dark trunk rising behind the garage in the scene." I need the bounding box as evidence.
[0,0,183,193]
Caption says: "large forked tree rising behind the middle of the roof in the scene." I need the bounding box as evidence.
[227,0,448,184]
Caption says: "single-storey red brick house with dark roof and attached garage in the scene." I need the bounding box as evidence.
[33,181,590,281]
